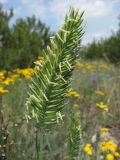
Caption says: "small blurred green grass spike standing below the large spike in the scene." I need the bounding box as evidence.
[68,112,81,160]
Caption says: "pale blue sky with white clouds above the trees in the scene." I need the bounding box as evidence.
[0,0,120,44]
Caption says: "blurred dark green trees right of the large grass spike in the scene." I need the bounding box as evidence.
[81,15,120,63]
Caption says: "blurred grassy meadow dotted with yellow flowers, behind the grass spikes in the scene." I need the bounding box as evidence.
[0,59,120,160]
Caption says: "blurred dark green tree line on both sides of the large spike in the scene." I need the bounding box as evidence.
[0,5,120,70]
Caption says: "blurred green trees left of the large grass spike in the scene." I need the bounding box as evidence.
[0,6,52,70]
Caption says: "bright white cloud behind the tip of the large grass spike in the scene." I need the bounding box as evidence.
[50,0,113,18]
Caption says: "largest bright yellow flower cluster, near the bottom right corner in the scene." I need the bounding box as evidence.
[101,140,117,152]
